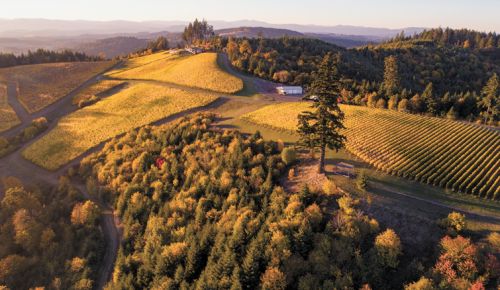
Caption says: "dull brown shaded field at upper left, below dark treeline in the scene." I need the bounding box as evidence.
[0,61,113,113]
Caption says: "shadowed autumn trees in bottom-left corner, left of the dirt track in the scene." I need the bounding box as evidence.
[0,177,104,290]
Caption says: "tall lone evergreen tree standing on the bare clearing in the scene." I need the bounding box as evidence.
[297,53,346,173]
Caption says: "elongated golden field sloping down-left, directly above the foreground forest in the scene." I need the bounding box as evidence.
[22,84,218,170]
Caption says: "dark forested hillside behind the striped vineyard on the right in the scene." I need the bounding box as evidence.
[221,29,500,125]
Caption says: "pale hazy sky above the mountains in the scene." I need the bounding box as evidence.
[0,0,500,32]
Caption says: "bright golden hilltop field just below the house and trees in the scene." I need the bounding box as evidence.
[108,52,243,94]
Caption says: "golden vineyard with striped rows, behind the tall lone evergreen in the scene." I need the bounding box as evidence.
[242,102,500,199]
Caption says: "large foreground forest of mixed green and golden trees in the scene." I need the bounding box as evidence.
[79,114,499,289]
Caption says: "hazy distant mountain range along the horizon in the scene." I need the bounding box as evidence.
[0,19,423,57]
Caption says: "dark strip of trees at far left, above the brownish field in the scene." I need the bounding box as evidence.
[0,49,102,67]
